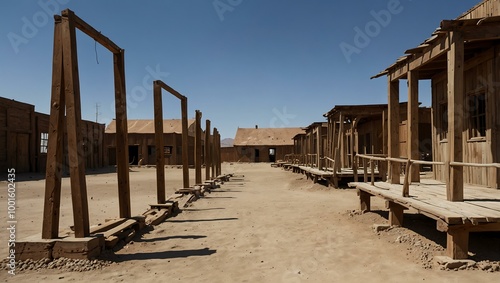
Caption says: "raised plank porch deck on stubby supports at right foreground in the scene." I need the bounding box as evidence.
[349,179,500,259]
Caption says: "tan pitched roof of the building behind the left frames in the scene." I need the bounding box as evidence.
[105,119,195,136]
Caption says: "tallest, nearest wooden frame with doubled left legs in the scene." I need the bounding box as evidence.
[42,10,131,239]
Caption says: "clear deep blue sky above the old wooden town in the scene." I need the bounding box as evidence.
[0,0,480,138]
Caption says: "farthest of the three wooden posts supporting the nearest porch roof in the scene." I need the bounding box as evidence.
[388,76,400,184]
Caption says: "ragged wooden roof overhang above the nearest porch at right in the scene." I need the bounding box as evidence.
[371,16,500,81]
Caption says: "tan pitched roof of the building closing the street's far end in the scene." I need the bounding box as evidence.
[234,128,304,146]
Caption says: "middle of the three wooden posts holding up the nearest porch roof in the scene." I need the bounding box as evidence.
[406,71,420,182]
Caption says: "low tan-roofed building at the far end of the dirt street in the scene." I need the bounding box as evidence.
[233,126,304,162]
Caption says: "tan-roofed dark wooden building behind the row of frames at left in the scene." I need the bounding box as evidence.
[105,119,196,165]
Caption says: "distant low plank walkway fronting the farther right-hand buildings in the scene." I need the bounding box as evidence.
[281,164,380,188]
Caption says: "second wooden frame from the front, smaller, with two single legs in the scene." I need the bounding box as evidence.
[153,80,189,204]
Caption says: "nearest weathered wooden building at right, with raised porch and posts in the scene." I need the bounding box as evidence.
[352,0,500,259]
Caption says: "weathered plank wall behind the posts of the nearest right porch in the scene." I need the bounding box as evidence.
[432,45,500,188]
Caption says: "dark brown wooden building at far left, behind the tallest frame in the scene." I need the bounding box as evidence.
[0,97,104,173]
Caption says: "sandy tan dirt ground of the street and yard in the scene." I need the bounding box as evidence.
[0,163,500,282]
